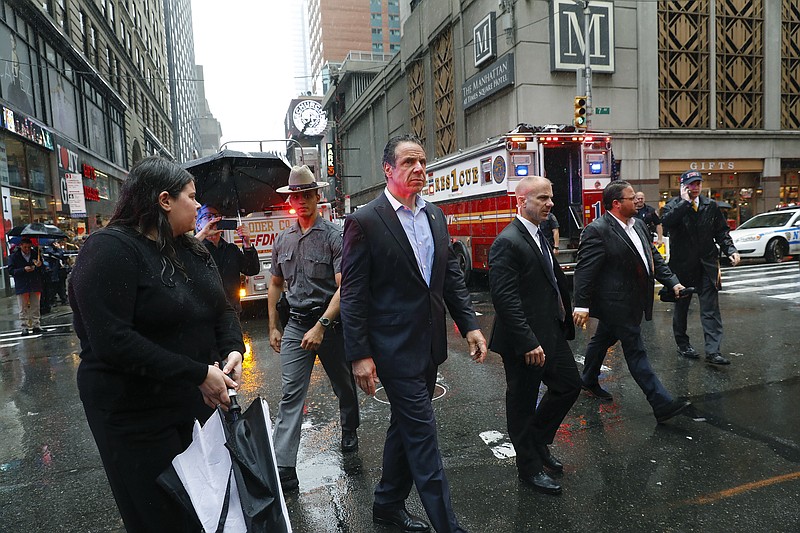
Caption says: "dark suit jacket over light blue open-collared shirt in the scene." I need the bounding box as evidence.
[340,194,478,377]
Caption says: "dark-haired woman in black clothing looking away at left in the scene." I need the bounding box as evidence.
[69,158,244,533]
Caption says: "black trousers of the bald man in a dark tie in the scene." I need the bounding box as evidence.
[503,335,581,476]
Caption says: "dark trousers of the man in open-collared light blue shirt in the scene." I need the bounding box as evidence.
[375,361,464,533]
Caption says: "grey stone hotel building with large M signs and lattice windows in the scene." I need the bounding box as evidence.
[323,0,800,226]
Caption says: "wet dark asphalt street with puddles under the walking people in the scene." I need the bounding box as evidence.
[0,262,800,533]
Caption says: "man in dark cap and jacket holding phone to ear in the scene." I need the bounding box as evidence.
[661,170,740,365]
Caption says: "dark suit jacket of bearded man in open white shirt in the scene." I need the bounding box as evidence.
[574,213,678,325]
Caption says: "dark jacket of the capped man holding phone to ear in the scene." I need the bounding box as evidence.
[661,195,736,285]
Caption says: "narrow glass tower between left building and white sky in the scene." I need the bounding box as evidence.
[163,0,200,161]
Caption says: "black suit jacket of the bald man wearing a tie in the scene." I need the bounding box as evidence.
[489,218,575,356]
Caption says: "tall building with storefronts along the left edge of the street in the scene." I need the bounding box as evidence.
[0,0,177,287]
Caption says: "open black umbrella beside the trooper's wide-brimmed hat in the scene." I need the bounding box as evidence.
[183,150,290,216]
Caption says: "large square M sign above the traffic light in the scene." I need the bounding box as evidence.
[550,0,615,73]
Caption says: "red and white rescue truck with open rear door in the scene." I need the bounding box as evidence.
[422,124,616,279]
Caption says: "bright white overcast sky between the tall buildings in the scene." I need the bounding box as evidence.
[192,0,294,148]
